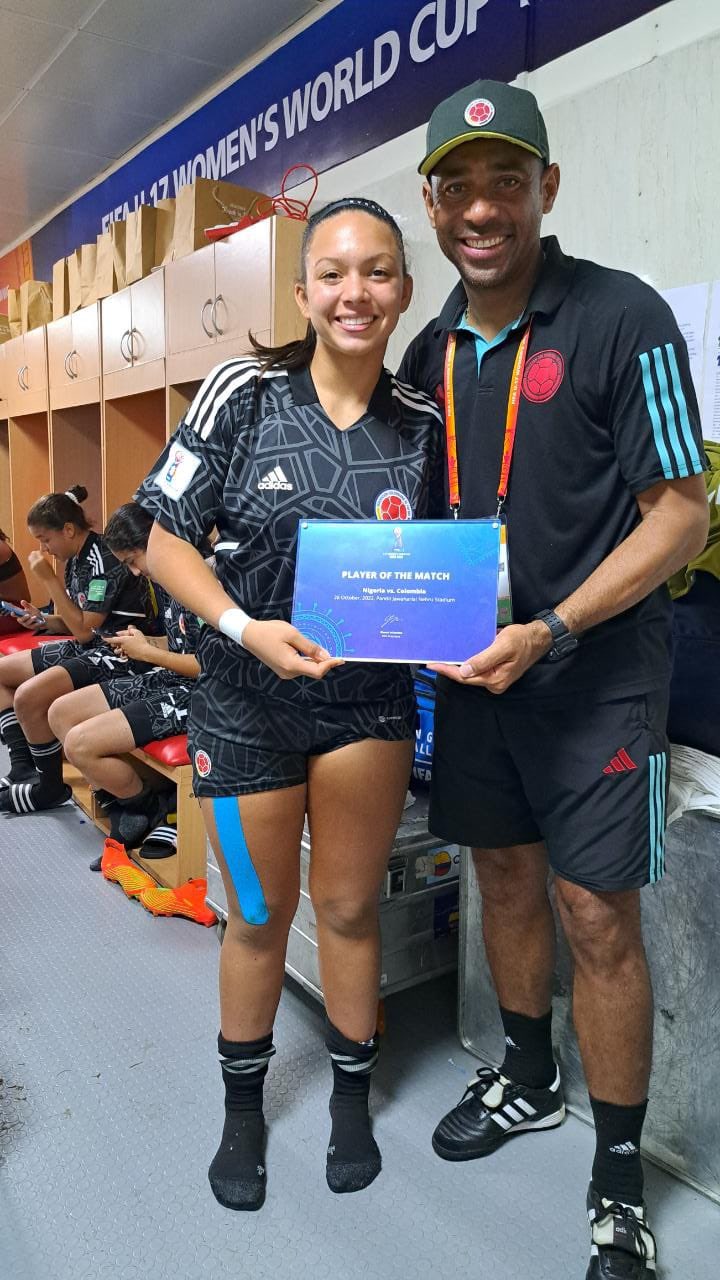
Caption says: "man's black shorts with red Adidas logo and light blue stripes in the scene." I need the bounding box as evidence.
[429,677,669,892]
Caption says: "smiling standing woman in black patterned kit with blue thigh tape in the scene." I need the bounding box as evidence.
[137,198,442,1210]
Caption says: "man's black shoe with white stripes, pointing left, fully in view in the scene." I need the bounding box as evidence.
[433,1066,565,1160]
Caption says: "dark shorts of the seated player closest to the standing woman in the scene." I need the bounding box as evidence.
[100,669,193,746]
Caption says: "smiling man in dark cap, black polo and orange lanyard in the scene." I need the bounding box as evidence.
[400,81,707,1280]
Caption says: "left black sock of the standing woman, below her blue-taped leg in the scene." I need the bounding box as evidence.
[208,1032,275,1210]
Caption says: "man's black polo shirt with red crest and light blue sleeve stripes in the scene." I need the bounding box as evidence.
[398,237,706,698]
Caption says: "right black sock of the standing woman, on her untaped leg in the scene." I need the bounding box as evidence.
[325,1019,382,1193]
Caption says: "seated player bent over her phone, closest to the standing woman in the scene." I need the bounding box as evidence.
[47,502,200,860]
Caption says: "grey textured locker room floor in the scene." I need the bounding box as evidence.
[0,762,720,1280]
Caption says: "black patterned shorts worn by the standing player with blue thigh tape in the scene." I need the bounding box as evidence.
[188,678,415,796]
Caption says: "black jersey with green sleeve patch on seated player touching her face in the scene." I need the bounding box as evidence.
[65,531,149,635]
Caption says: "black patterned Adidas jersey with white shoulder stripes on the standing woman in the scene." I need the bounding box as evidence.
[136,358,443,721]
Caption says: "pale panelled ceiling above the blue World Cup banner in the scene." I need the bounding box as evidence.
[0,0,328,255]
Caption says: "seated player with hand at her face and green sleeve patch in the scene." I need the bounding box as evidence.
[0,485,147,814]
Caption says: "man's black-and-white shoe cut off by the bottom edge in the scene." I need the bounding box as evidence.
[585,1183,657,1280]
